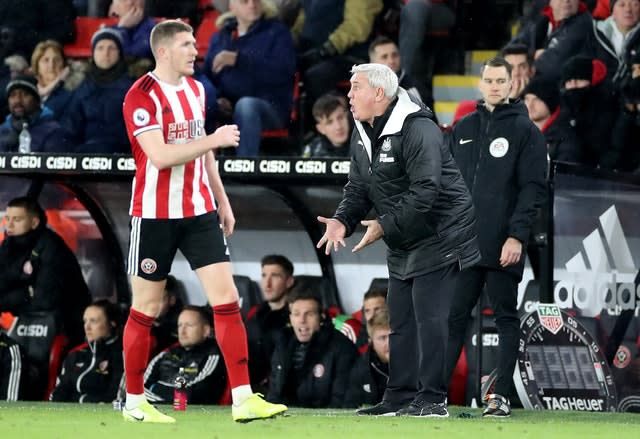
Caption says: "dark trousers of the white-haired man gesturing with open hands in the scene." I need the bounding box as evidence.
[384,263,459,405]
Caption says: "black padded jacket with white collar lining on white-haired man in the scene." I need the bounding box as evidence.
[334,88,480,279]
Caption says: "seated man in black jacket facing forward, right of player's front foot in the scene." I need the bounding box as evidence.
[267,288,358,408]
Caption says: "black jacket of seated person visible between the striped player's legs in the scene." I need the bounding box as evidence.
[144,338,227,404]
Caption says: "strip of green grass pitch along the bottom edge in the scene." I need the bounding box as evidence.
[0,402,640,439]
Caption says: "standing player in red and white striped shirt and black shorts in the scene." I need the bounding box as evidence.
[122,20,287,423]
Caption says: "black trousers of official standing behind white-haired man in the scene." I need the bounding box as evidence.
[445,267,520,397]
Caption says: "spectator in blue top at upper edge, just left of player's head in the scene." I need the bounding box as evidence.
[109,0,155,59]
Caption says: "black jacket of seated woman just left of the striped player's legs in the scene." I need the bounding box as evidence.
[50,336,124,402]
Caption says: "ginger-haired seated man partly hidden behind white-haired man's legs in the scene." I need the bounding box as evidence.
[344,307,391,407]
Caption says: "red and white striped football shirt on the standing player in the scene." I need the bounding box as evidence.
[122,73,216,219]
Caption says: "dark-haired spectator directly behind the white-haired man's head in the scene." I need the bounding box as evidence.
[369,36,438,114]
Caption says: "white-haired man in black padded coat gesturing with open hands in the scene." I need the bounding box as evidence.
[318,64,480,417]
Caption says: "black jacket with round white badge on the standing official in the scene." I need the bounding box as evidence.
[450,100,547,277]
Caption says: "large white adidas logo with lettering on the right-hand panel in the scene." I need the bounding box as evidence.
[553,205,640,317]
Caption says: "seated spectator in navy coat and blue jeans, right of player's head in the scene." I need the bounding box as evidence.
[204,0,295,157]
